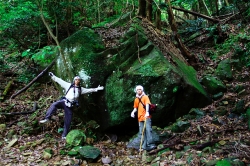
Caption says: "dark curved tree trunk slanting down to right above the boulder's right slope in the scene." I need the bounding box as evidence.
[166,0,196,66]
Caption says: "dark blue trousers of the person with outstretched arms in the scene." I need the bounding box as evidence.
[45,100,73,137]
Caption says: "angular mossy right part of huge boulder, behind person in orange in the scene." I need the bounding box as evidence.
[105,46,209,126]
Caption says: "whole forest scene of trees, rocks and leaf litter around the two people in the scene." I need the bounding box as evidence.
[0,0,250,166]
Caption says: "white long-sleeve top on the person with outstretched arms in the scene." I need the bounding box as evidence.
[51,75,98,102]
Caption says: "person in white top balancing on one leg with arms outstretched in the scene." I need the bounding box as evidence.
[40,72,104,139]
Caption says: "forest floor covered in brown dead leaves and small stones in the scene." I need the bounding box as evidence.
[0,20,250,166]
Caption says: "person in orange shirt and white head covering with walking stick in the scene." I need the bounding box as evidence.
[131,85,156,151]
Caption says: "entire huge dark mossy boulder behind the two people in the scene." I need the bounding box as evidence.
[50,18,210,132]
